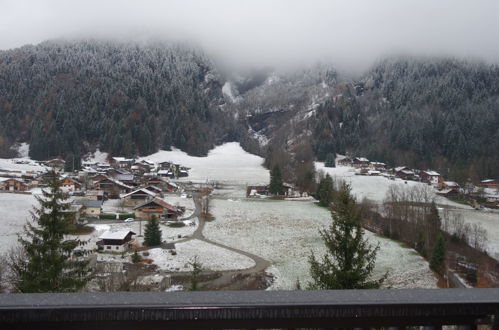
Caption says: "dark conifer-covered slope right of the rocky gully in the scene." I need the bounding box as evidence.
[314,58,499,177]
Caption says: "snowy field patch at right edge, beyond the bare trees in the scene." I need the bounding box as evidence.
[440,209,499,260]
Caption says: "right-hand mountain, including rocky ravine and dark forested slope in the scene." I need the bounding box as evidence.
[230,57,499,179]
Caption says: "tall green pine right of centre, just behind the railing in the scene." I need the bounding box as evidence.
[308,183,386,290]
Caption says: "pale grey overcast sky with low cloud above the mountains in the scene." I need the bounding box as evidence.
[0,0,499,68]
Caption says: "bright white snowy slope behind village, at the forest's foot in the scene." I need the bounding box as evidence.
[142,142,270,184]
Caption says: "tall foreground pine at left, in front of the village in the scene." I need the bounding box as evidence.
[9,171,91,293]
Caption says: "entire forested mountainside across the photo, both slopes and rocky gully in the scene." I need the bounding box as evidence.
[0,40,499,179]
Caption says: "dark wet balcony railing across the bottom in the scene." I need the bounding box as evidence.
[0,289,499,330]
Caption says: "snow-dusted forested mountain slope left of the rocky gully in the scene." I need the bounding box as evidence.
[0,40,231,159]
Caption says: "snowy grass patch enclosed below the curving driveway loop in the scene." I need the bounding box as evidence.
[147,240,255,271]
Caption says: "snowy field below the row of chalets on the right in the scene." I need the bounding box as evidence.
[315,162,469,208]
